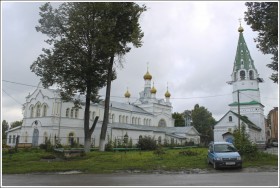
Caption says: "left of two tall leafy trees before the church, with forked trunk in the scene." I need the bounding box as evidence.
[30,3,114,152]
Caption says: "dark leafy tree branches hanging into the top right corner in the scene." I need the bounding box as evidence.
[244,2,278,83]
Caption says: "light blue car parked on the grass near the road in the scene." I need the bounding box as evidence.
[207,142,242,169]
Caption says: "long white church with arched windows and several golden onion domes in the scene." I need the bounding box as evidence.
[7,70,200,147]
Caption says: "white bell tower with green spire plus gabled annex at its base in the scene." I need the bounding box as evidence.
[214,26,265,142]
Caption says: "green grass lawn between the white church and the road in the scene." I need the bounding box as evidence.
[2,148,278,174]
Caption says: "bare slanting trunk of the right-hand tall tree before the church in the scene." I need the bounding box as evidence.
[99,56,114,151]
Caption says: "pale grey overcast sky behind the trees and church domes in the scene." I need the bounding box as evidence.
[1,1,278,123]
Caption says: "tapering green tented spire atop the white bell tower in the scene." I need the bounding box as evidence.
[233,26,257,72]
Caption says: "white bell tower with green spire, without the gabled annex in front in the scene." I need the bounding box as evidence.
[227,24,265,140]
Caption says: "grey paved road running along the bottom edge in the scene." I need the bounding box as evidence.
[2,172,278,186]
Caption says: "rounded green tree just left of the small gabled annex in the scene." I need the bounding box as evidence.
[191,104,216,144]
